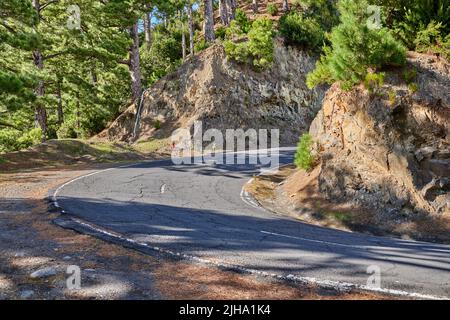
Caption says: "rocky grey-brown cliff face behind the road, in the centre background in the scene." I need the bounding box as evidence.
[100,41,325,145]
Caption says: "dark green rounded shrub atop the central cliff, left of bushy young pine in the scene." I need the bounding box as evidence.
[279,12,325,51]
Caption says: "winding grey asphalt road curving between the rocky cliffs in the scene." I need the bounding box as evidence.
[55,150,450,297]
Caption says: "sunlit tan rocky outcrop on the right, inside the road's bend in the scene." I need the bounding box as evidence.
[310,54,450,218]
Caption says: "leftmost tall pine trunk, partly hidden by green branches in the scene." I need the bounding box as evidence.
[32,0,48,142]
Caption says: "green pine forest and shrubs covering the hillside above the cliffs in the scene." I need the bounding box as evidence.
[0,0,450,152]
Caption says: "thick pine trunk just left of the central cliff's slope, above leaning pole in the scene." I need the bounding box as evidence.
[129,22,142,102]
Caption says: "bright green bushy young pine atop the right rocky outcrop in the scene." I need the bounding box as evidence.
[307,0,406,90]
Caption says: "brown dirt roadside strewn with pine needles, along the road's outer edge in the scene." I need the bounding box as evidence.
[0,164,398,299]
